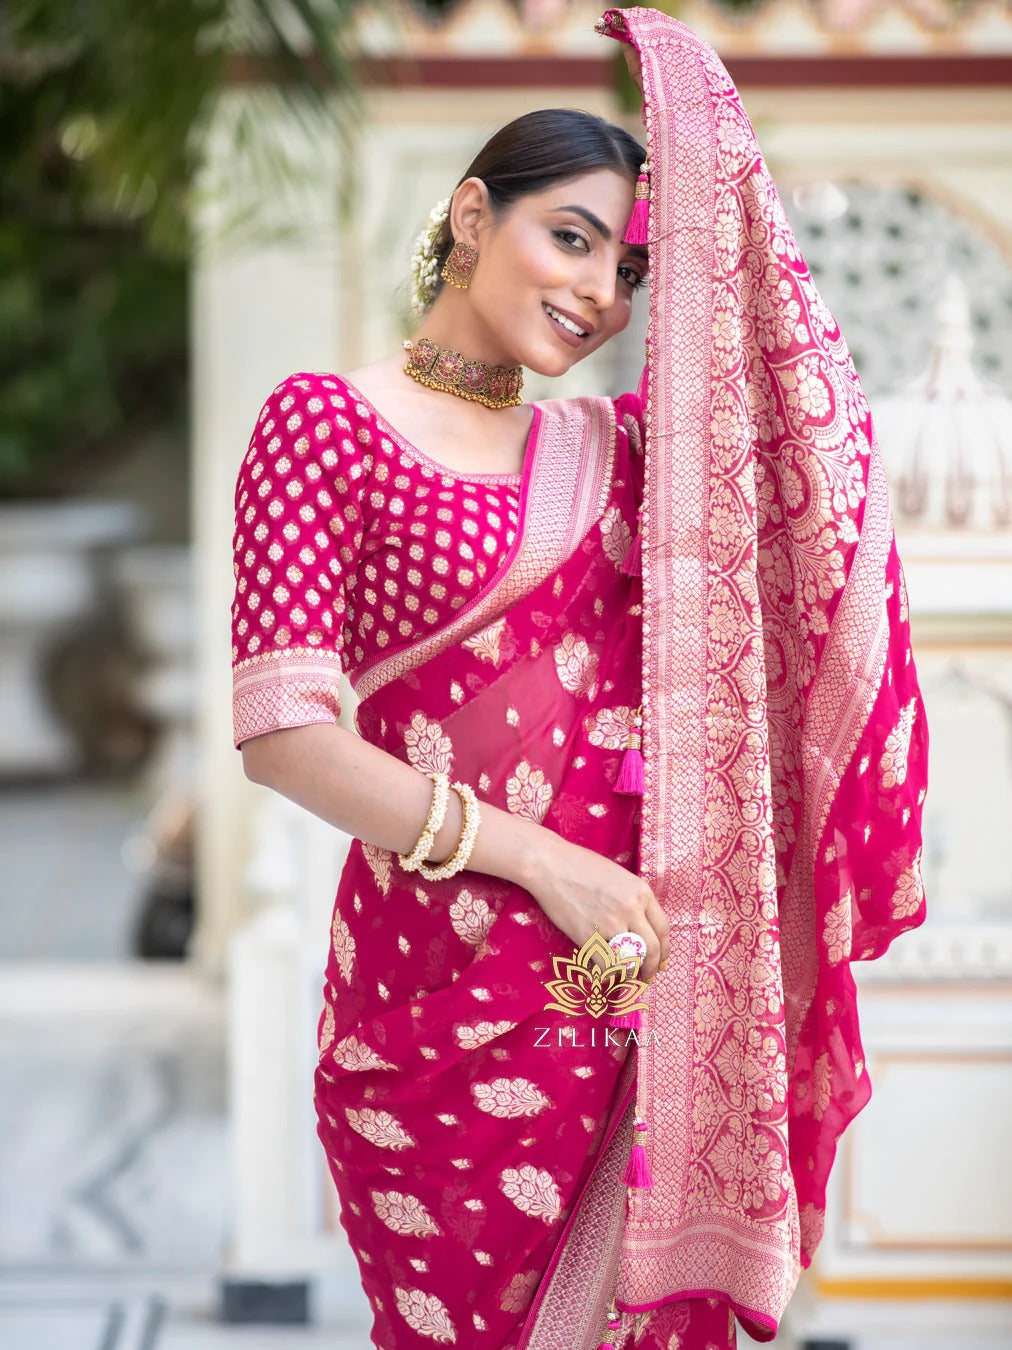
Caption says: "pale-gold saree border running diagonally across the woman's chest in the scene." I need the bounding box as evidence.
[351,397,618,701]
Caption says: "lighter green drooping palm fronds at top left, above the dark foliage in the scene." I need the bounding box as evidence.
[0,0,359,255]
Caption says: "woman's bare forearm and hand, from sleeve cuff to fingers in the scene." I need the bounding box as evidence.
[242,722,668,980]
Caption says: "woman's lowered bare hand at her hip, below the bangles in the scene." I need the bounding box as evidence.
[524,830,669,980]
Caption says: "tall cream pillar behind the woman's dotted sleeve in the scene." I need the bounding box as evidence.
[190,89,340,968]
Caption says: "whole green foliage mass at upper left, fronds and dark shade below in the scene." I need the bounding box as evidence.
[0,0,355,495]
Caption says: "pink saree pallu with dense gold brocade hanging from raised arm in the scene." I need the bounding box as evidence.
[529,8,927,1350]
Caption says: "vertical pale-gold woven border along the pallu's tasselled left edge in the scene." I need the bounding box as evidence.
[631,0,723,1305]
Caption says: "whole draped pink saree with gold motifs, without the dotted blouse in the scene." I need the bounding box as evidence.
[317,9,927,1350]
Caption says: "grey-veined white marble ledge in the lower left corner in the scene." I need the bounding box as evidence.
[0,963,371,1350]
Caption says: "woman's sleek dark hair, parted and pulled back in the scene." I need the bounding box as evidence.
[433,108,646,294]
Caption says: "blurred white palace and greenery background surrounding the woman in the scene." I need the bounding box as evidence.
[0,0,1012,1350]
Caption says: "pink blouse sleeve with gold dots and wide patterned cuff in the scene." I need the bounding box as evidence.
[232,374,363,749]
